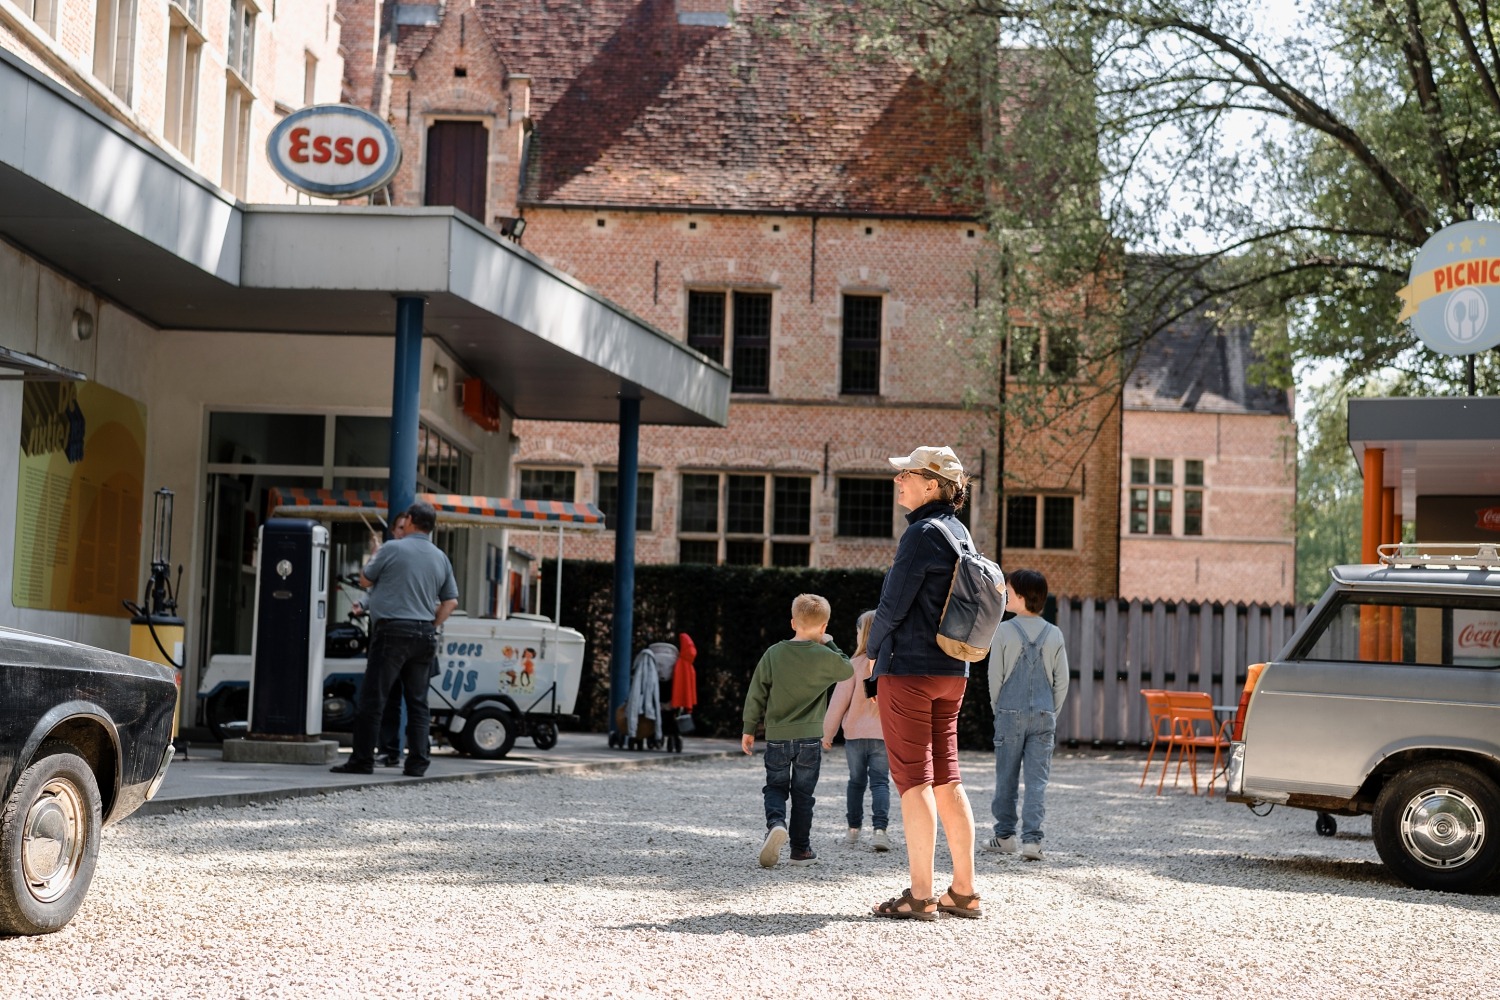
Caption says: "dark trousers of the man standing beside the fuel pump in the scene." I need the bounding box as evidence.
[350,624,437,774]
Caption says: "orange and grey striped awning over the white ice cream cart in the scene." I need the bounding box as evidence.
[269,486,605,531]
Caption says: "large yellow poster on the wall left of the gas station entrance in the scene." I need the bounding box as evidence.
[11,382,146,618]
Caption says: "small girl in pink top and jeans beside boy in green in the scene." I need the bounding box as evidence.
[824,612,891,852]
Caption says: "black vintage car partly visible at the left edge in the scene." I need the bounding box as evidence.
[0,627,177,934]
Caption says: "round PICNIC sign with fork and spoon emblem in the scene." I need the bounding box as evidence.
[1397,222,1500,355]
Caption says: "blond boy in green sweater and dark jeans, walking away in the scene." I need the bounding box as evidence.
[740,594,854,868]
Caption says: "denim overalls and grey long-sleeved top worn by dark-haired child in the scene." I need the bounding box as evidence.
[990,619,1058,844]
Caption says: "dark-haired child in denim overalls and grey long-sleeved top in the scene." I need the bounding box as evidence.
[984,570,1068,861]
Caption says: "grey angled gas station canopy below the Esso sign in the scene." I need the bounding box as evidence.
[0,49,729,426]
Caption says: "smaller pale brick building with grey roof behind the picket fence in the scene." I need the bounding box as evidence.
[1119,309,1296,604]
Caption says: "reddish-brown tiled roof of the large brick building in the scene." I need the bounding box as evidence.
[462,0,978,217]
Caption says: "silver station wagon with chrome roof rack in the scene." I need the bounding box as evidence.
[1227,543,1500,892]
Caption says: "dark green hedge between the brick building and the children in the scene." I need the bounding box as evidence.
[542,559,993,750]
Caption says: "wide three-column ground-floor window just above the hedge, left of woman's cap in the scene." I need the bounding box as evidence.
[678,472,813,565]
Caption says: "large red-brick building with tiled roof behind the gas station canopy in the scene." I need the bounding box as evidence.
[351,0,1121,595]
